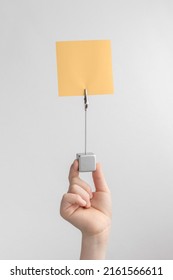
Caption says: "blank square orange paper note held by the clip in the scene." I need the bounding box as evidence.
[56,40,114,96]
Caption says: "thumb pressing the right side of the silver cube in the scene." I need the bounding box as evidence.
[92,163,109,192]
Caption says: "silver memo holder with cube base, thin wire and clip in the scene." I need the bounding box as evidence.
[76,89,96,172]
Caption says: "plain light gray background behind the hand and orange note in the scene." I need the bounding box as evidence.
[0,0,173,259]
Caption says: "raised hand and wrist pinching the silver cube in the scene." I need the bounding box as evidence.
[60,160,111,259]
